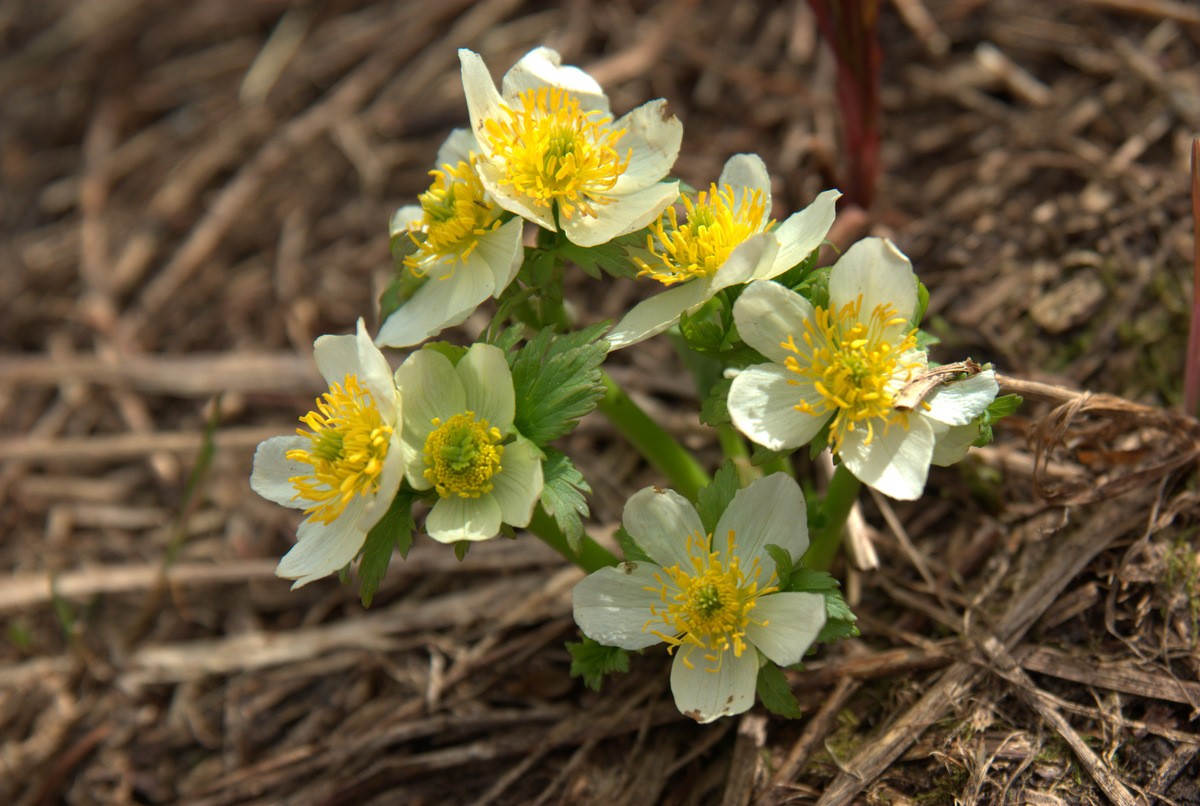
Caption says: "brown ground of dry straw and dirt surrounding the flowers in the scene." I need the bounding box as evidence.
[0,0,1200,805]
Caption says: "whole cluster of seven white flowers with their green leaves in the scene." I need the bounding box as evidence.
[251,48,1010,722]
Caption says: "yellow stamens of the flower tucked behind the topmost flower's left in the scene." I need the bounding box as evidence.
[404,162,502,279]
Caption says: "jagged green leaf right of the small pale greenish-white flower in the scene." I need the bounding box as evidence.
[509,323,608,447]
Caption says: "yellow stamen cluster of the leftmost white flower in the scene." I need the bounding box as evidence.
[287,375,392,523]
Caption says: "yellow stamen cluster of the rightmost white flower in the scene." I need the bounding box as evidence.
[781,295,920,453]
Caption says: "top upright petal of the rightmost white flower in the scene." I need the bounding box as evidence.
[829,237,917,319]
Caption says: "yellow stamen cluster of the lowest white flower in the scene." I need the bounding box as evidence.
[642,530,779,673]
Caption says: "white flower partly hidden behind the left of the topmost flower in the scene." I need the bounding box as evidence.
[376,130,524,347]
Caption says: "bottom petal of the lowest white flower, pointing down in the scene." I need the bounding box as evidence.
[671,645,758,723]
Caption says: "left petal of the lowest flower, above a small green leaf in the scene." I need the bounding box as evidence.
[571,563,662,650]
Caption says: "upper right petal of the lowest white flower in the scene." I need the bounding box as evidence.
[713,473,809,566]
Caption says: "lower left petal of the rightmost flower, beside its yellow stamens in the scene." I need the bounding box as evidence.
[728,363,829,451]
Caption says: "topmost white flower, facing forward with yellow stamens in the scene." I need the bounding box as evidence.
[458,48,683,246]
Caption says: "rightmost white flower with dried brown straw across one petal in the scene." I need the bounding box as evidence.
[728,237,998,500]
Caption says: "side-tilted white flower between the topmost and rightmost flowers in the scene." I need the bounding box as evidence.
[606,154,841,350]
